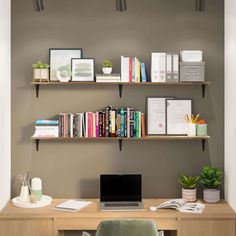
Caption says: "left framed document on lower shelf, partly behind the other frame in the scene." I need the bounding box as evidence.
[146,97,174,136]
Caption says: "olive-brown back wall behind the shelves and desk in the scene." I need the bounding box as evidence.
[12,0,224,201]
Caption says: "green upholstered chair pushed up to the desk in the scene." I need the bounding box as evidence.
[83,220,164,236]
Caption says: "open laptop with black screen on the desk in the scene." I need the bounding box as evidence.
[100,174,144,211]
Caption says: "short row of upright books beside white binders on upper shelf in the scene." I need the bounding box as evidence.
[121,56,147,83]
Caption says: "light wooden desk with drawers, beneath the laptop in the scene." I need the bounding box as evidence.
[0,199,235,236]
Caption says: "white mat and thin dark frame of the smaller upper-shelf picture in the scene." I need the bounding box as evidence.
[71,59,95,82]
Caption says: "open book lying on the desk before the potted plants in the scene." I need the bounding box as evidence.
[156,198,205,214]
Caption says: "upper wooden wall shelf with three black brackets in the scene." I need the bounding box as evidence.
[31,81,210,98]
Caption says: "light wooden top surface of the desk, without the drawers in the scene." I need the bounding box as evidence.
[0,199,235,220]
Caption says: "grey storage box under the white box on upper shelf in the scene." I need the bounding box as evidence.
[180,62,205,82]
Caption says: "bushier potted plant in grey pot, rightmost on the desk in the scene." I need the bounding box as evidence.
[200,166,223,203]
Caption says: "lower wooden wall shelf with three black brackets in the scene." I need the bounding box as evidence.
[31,135,210,151]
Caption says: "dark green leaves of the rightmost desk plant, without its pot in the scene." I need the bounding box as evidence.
[200,166,223,189]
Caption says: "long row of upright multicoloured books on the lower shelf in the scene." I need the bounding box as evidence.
[59,106,145,138]
